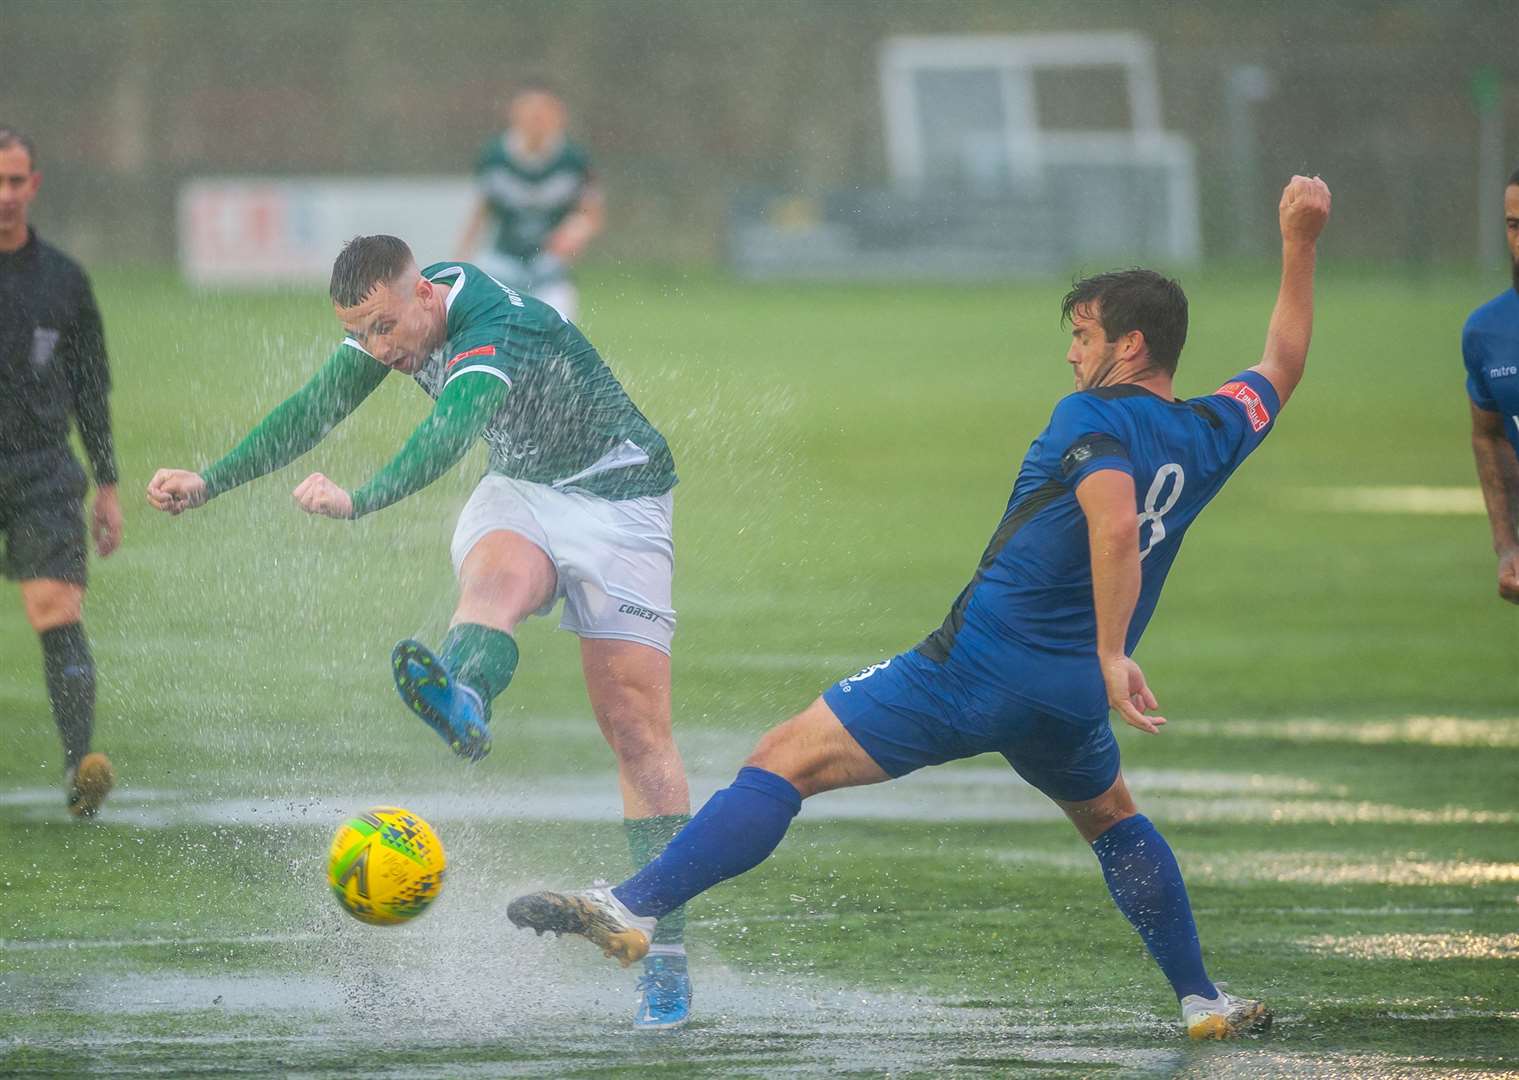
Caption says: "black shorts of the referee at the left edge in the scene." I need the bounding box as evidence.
[0,448,88,585]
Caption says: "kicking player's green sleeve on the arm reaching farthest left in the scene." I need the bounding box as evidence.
[201,342,390,498]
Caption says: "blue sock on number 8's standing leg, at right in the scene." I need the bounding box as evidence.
[1092,814,1218,998]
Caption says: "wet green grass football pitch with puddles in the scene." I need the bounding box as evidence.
[0,266,1519,1077]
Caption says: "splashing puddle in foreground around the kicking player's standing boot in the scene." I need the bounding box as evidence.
[0,960,1182,1077]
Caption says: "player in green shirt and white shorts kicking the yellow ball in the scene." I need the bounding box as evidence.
[147,235,691,1028]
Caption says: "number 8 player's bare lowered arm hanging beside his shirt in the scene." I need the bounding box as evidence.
[1075,469,1165,735]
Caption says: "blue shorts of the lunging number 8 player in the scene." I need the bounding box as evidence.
[823,652,1118,802]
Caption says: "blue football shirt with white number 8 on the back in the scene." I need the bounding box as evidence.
[917,371,1279,723]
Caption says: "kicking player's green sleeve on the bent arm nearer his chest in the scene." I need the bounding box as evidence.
[352,371,510,518]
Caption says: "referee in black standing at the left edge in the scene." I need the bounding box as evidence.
[0,126,122,817]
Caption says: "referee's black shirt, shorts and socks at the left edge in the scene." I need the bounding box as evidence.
[0,231,115,778]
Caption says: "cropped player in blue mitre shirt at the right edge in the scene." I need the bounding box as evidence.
[1461,169,1519,603]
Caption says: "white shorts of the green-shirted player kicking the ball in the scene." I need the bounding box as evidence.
[451,472,674,655]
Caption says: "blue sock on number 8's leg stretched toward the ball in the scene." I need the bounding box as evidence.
[612,766,808,923]
